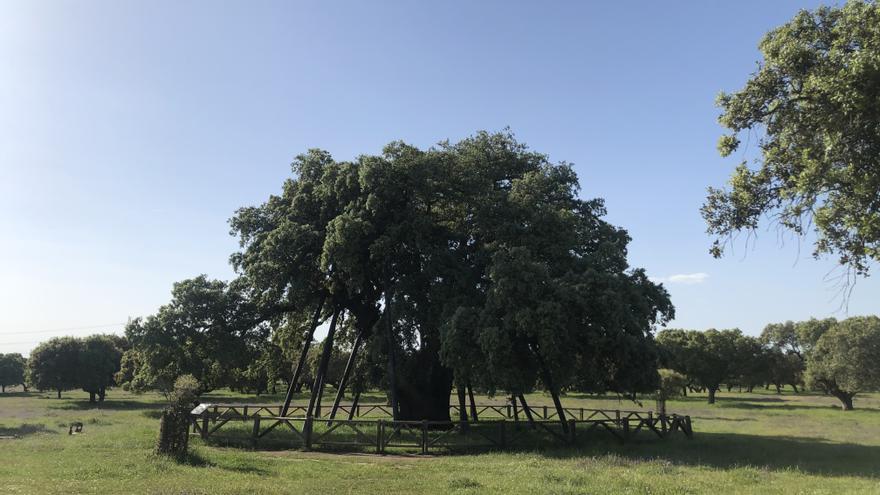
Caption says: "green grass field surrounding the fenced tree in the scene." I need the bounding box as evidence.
[0,390,880,494]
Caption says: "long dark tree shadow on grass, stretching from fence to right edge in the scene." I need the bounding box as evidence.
[540,432,880,478]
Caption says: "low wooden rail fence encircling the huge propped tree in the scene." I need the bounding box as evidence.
[191,404,693,454]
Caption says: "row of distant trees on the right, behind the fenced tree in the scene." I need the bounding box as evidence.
[657,316,880,410]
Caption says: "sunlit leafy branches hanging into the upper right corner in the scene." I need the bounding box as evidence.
[702,0,880,274]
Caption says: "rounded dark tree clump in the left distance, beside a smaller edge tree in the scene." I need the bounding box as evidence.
[25,335,129,402]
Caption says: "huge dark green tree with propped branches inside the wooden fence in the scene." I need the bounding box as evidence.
[231,133,673,419]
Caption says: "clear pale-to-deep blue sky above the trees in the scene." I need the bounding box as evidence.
[0,0,880,353]
